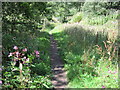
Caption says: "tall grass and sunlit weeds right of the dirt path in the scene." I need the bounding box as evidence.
[50,16,118,88]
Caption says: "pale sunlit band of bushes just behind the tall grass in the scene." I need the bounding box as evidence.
[69,11,120,25]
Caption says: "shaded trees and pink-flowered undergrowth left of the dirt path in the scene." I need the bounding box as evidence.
[2,2,52,89]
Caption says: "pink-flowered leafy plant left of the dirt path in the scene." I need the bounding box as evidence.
[3,46,40,88]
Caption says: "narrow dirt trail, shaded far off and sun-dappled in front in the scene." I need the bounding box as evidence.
[50,35,67,88]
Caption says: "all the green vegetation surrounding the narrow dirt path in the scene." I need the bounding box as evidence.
[0,2,120,89]
